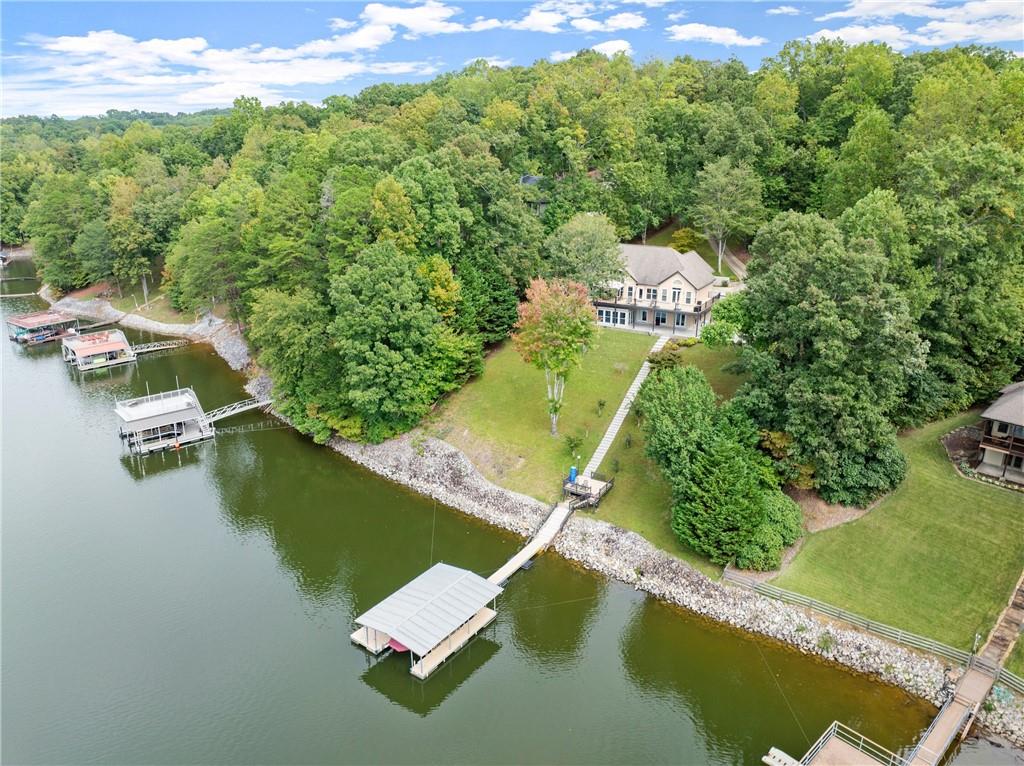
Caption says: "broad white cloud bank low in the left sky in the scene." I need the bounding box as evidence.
[2,25,437,116]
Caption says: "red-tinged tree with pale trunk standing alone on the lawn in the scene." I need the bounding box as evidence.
[512,279,597,436]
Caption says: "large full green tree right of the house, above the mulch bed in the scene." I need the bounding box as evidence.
[738,213,925,505]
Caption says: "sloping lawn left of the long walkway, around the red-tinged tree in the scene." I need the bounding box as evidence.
[429,329,654,502]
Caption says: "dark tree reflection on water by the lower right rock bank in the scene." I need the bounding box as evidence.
[621,598,935,761]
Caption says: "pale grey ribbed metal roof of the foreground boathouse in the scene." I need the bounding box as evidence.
[355,564,502,656]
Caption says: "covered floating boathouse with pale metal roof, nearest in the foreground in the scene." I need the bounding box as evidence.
[351,563,503,679]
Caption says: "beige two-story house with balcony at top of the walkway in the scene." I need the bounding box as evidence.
[594,245,722,336]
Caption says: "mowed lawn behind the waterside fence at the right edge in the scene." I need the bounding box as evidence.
[773,413,1024,651]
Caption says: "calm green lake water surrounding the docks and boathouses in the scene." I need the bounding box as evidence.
[2,262,1020,764]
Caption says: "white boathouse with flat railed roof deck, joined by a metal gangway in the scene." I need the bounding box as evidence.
[114,388,215,455]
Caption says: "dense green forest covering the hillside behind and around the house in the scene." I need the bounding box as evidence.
[8,41,1024,503]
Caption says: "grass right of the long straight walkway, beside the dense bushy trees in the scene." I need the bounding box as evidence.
[595,345,743,577]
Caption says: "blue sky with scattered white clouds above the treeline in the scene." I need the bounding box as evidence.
[0,0,1024,116]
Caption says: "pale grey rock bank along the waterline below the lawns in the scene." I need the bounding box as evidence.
[319,434,1024,746]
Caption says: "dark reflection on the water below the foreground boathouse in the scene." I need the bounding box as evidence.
[359,628,501,717]
